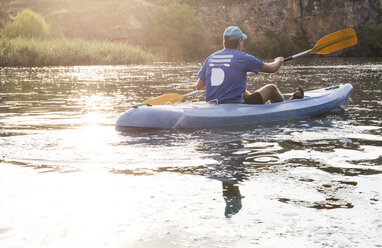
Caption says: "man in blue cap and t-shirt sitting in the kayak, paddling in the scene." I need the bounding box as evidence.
[196,26,303,104]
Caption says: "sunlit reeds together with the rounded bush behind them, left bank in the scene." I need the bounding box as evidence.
[0,10,156,66]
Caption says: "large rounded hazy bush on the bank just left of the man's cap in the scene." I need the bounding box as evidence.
[149,2,209,59]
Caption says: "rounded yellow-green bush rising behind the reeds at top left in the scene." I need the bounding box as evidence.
[1,9,50,39]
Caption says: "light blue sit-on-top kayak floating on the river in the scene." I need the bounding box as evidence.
[116,84,353,129]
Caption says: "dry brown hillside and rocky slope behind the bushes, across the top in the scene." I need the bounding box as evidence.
[0,0,382,56]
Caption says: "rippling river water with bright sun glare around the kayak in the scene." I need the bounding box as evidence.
[0,57,382,248]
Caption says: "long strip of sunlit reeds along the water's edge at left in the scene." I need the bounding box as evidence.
[0,38,157,66]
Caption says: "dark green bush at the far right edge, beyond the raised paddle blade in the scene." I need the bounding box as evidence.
[365,23,382,56]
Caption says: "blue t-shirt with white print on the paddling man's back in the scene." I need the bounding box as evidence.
[198,49,264,103]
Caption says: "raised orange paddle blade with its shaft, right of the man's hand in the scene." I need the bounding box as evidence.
[284,28,358,61]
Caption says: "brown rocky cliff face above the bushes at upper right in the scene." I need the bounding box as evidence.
[188,0,382,41]
